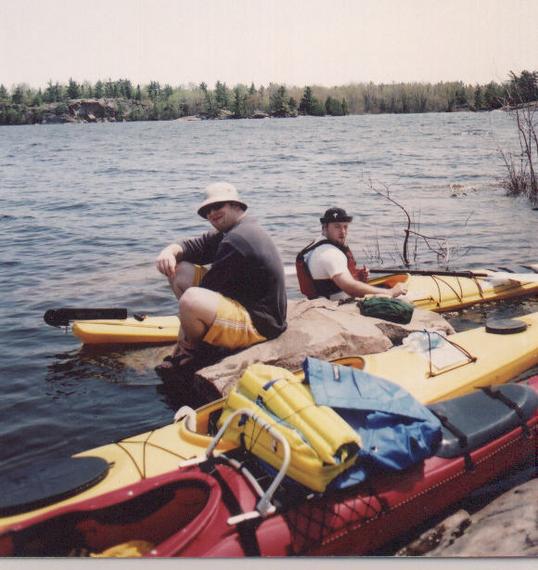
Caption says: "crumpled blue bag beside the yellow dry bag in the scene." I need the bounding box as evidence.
[303,357,441,488]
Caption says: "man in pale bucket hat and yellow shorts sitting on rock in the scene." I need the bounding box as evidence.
[155,182,287,372]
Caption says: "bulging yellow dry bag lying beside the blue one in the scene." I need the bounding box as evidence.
[219,363,360,492]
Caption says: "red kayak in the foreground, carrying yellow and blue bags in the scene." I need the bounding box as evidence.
[0,379,538,557]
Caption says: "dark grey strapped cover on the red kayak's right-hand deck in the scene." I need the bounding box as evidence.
[428,384,538,458]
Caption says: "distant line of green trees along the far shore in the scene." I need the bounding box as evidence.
[0,71,538,125]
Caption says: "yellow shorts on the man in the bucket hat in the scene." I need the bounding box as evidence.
[204,295,267,350]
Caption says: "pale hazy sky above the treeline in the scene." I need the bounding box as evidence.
[0,0,538,87]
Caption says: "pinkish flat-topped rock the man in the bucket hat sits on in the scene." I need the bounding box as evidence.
[196,299,454,395]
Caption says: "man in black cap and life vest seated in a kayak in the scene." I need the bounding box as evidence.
[296,208,406,300]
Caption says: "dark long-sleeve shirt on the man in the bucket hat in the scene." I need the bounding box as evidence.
[180,216,287,338]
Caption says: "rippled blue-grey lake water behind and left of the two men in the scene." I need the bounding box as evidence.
[0,112,538,484]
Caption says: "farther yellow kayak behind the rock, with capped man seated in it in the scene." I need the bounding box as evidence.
[69,270,538,344]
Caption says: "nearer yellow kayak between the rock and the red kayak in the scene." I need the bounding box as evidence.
[4,312,538,526]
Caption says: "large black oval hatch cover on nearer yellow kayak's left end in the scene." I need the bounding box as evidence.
[0,457,109,517]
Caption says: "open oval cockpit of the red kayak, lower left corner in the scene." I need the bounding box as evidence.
[0,474,216,557]
